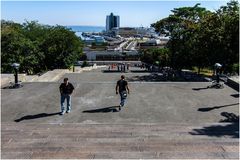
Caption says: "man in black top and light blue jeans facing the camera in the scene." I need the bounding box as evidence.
[59,78,74,115]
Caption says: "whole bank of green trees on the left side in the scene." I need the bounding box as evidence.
[1,20,83,74]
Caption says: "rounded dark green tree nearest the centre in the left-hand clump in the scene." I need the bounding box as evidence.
[41,26,83,69]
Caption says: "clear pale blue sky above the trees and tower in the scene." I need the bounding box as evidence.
[1,0,227,27]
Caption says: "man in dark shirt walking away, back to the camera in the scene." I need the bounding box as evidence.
[116,75,130,110]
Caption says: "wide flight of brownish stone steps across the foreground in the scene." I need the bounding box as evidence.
[1,122,239,159]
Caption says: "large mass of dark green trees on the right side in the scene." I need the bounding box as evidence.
[152,1,239,74]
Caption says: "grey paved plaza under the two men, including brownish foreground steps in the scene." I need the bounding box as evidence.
[1,66,239,159]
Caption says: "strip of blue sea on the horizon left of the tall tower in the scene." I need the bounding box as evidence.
[66,26,105,32]
